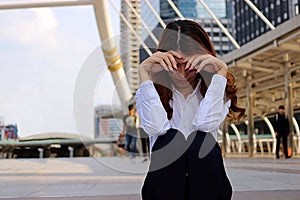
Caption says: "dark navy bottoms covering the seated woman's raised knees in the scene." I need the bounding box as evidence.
[142,129,232,200]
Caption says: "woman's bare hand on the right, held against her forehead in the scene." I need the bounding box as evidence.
[185,54,228,77]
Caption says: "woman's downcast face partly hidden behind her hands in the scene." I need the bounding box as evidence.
[169,55,198,89]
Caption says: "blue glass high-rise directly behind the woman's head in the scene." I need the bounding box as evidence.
[140,0,234,58]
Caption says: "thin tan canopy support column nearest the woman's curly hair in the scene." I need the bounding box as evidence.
[246,76,254,157]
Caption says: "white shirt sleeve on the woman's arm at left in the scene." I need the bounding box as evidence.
[135,80,170,136]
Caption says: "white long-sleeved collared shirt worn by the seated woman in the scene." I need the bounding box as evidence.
[135,74,230,149]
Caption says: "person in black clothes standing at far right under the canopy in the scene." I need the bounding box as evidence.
[274,105,290,159]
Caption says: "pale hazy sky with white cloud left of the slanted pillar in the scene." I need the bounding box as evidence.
[0,0,120,137]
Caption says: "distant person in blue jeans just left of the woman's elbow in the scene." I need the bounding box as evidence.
[123,104,137,158]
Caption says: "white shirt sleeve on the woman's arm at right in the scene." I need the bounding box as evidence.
[192,74,231,132]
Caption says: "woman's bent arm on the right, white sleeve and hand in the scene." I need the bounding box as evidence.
[186,54,231,132]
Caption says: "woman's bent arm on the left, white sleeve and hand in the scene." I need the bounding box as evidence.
[135,51,182,136]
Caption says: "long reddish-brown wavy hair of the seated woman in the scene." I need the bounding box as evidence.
[153,20,245,120]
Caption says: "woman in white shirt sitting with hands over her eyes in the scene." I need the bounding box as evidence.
[136,20,245,200]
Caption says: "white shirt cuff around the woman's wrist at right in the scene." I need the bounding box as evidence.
[207,74,227,97]
